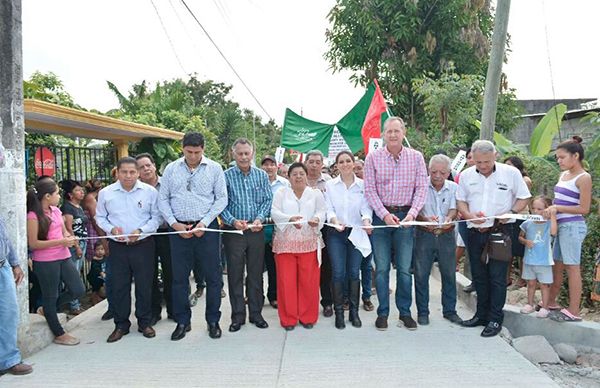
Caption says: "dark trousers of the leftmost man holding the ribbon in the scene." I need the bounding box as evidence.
[108,237,155,330]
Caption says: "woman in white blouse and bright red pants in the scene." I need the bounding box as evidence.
[271,163,326,330]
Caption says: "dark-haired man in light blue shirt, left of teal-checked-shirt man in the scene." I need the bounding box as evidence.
[158,132,227,341]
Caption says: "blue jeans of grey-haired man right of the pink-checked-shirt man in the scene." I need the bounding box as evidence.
[413,229,456,316]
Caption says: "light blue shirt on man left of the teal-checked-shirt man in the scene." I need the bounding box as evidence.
[158,156,227,227]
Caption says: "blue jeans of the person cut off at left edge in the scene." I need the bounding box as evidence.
[0,262,21,371]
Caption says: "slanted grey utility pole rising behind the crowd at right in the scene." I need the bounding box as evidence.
[479,0,510,140]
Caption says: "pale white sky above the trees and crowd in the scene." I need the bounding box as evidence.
[22,0,600,125]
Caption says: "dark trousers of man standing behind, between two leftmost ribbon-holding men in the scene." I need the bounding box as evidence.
[152,235,173,316]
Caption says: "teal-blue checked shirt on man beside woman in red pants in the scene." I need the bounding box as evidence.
[221,166,273,225]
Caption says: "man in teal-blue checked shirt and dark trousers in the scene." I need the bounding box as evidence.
[221,138,273,332]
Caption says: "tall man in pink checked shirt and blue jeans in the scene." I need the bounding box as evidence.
[364,117,427,330]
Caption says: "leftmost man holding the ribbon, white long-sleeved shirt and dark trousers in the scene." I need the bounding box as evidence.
[96,157,160,342]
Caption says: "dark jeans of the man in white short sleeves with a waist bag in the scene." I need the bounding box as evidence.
[466,224,513,324]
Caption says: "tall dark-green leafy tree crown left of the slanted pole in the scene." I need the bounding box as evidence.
[325,0,493,121]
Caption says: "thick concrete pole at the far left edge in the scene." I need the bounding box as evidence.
[0,0,29,344]
